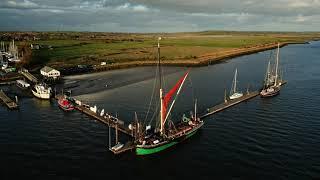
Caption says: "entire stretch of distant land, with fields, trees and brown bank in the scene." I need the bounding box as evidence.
[0,31,320,71]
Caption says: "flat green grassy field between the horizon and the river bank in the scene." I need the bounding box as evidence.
[15,31,320,68]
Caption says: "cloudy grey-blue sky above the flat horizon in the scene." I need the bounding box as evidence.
[0,0,320,32]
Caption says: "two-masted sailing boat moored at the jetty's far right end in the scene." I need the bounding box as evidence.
[260,43,281,98]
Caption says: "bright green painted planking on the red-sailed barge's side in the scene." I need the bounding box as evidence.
[136,130,197,155]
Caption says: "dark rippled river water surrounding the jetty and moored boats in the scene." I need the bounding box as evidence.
[0,42,320,179]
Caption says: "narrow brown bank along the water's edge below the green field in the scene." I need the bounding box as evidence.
[89,41,309,74]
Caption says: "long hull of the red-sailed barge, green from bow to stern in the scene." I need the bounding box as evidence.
[136,125,202,155]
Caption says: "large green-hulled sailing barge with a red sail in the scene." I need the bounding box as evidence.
[136,38,204,155]
